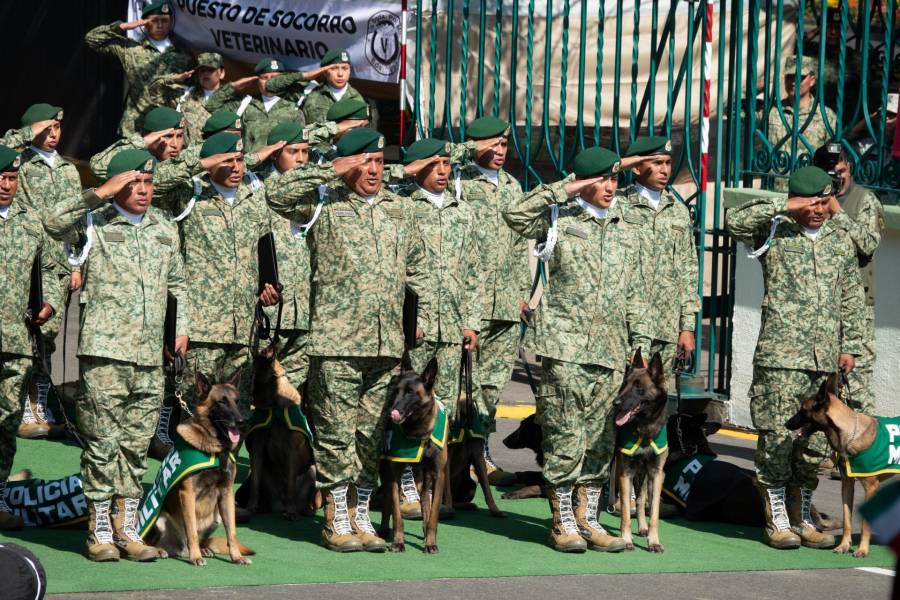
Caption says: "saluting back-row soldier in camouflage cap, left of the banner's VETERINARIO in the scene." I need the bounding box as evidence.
[147,52,225,144]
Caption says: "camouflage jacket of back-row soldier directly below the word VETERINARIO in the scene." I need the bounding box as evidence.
[206,83,306,152]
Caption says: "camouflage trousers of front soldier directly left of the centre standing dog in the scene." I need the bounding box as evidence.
[308,356,400,488]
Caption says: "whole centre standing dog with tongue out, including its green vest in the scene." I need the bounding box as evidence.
[379,358,449,554]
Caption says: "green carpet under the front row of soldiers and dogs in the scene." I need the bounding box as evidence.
[0,440,894,593]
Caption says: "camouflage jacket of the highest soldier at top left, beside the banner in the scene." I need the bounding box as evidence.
[84,21,196,137]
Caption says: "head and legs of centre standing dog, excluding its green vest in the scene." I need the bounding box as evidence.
[379,358,447,554]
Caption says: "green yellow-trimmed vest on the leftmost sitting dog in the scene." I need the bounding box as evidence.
[137,434,234,538]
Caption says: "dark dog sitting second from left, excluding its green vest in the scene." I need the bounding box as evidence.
[238,347,316,520]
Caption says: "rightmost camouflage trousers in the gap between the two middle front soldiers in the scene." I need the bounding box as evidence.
[472,321,519,433]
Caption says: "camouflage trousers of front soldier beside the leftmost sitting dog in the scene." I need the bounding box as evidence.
[76,356,163,502]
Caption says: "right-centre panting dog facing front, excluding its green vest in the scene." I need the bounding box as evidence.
[613,349,669,552]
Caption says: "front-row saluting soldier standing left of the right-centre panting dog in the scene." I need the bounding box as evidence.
[504,148,650,552]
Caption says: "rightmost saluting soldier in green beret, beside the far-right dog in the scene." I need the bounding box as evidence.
[727,167,865,548]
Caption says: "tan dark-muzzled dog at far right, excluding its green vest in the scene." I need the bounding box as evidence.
[785,373,892,558]
